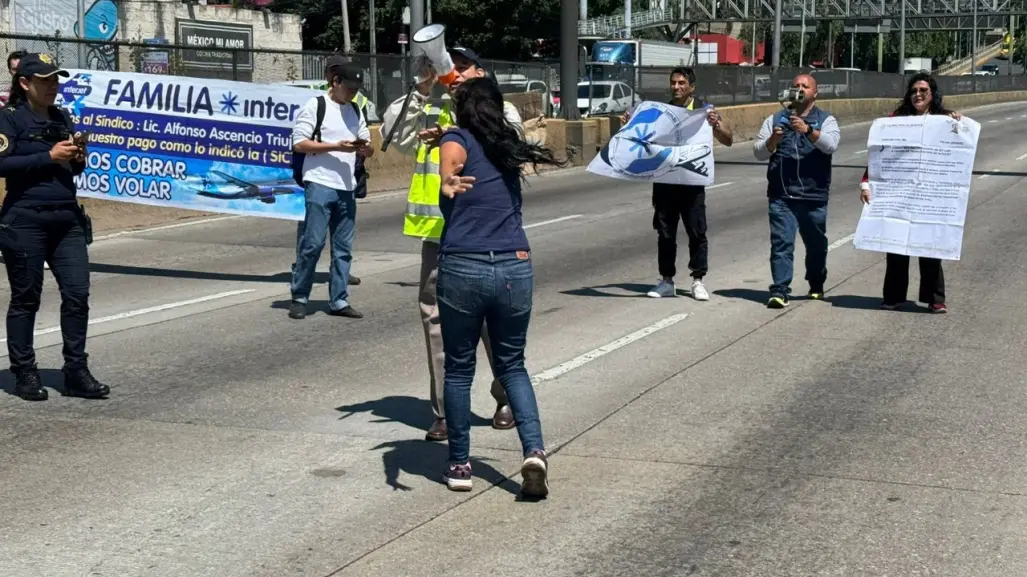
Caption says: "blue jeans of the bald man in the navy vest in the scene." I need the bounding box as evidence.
[770,198,828,297]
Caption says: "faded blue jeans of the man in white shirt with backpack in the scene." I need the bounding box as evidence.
[291,183,356,310]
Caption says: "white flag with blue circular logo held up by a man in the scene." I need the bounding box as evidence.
[588,101,714,186]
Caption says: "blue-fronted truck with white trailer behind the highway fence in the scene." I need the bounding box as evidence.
[586,39,718,103]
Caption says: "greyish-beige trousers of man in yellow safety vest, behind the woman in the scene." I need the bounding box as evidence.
[418,242,508,419]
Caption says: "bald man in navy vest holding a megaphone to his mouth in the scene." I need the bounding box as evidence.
[753,74,841,309]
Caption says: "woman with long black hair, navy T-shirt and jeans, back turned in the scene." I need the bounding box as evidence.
[436,78,566,497]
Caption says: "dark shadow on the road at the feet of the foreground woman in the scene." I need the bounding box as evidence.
[372,439,521,496]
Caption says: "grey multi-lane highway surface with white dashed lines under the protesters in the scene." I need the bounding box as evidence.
[0,104,1027,577]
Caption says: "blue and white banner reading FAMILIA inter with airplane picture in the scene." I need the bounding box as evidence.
[58,70,322,221]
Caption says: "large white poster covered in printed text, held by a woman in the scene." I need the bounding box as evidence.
[852,115,981,261]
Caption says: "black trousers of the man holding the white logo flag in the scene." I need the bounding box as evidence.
[652,183,709,278]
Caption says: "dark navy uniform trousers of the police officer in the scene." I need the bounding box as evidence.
[0,204,89,372]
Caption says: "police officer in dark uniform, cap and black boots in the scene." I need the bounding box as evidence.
[0,54,110,400]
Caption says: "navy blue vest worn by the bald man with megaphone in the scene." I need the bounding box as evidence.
[767,106,831,202]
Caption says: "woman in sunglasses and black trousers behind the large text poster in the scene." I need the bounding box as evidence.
[860,72,962,313]
